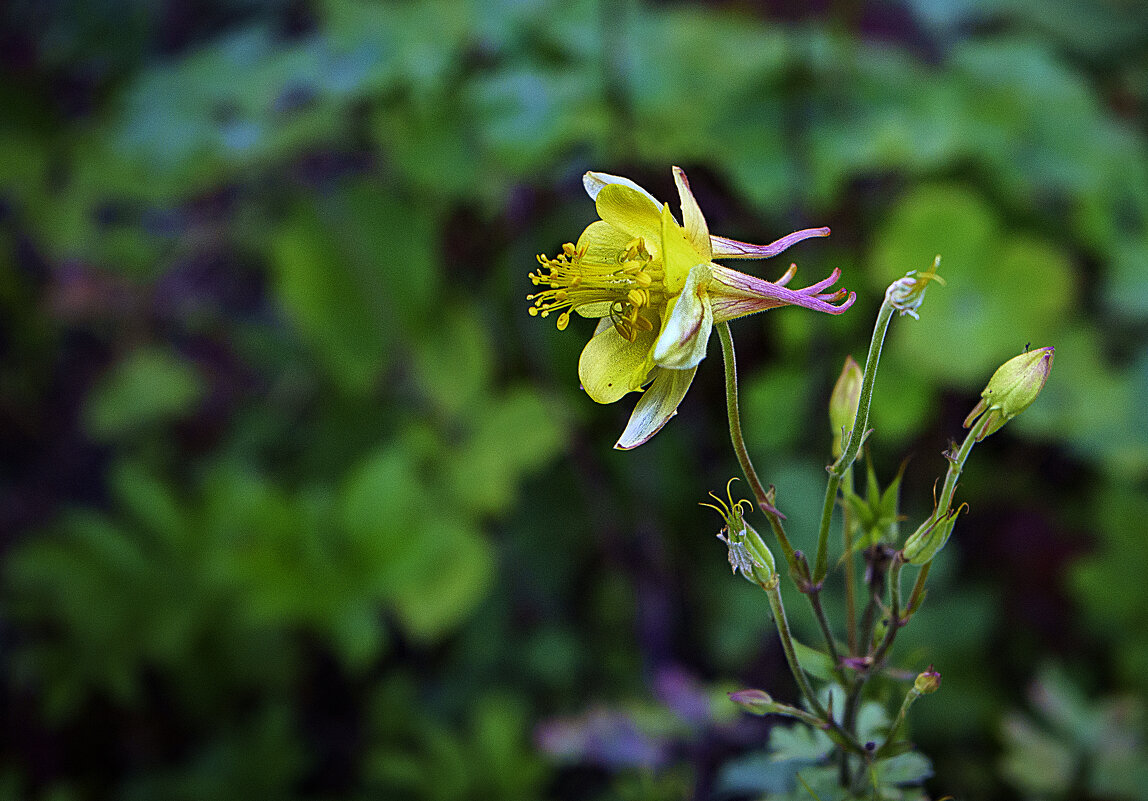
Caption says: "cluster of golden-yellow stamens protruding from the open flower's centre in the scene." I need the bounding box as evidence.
[527,236,665,342]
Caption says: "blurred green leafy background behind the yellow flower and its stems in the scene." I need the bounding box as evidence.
[0,0,1148,801]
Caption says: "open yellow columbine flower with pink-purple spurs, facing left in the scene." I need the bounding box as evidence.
[528,166,855,450]
